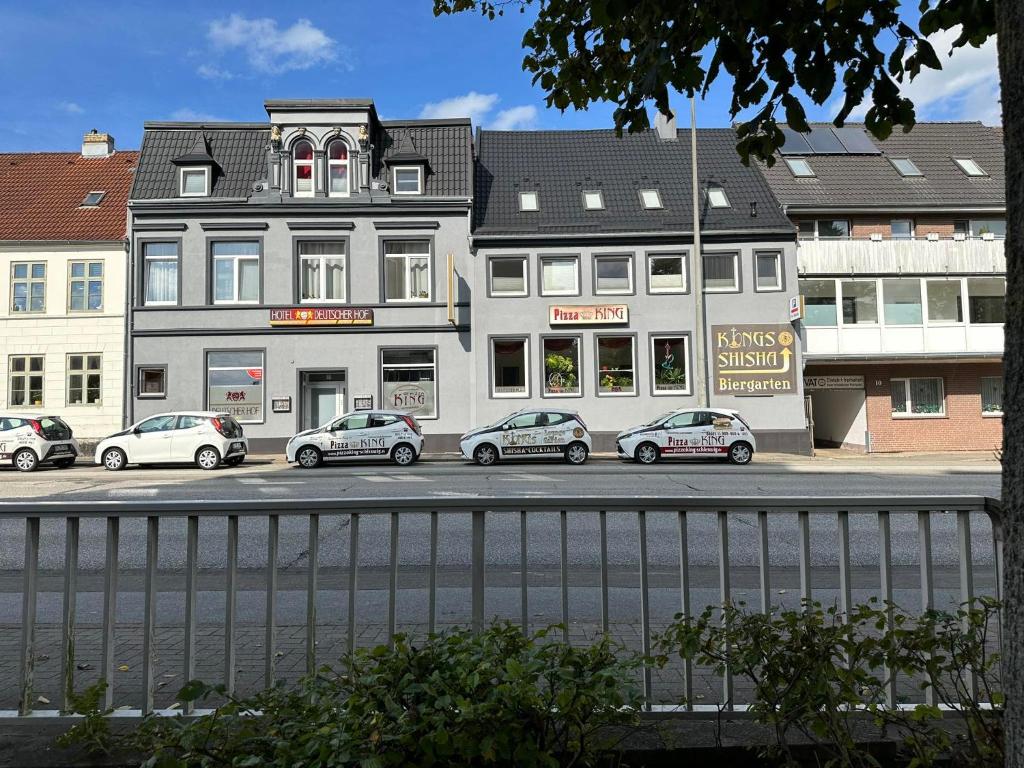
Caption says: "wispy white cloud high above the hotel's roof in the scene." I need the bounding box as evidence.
[207,13,340,75]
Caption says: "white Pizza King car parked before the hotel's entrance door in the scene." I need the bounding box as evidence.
[285,411,423,469]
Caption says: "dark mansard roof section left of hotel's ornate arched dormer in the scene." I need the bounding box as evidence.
[131,123,270,200]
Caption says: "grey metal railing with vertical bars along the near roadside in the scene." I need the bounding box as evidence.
[0,496,1002,717]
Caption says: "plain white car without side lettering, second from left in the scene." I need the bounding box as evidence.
[95,411,249,472]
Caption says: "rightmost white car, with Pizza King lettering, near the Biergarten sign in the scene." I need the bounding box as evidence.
[615,408,757,464]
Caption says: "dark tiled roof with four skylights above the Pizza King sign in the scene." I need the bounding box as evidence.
[474,128,793,236]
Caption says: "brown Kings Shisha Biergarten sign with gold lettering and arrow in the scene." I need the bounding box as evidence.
[711,325,797,394]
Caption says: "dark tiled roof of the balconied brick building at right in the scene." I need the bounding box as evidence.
[761,123,1006,209]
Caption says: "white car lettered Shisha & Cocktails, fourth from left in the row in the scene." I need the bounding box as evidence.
[459,408,593,466]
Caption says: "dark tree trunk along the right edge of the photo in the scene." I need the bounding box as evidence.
[995,0,1024,768]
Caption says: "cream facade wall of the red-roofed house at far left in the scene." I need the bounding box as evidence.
[0,243,126,441]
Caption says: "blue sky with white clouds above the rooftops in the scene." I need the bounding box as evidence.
[0,0,999,152]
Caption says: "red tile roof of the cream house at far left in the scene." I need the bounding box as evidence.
[0,152,138,241]
